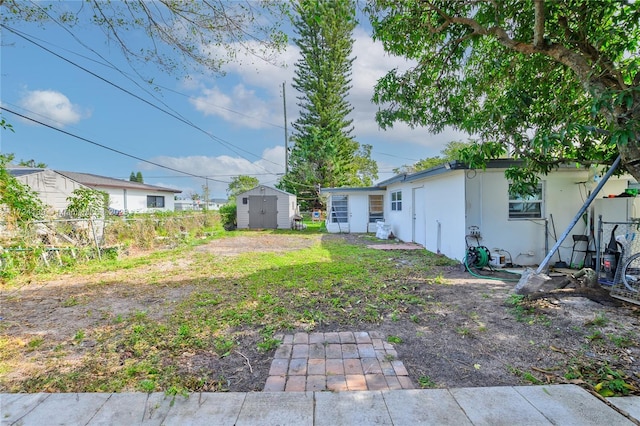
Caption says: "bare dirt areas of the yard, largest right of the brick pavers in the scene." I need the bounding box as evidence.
[0,231,640,393]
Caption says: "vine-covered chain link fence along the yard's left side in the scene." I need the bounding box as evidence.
[0,212,219,278]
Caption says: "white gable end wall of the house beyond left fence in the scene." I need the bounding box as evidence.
[16,169,85,213]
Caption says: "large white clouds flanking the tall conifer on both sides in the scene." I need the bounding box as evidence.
[192,27,467,158]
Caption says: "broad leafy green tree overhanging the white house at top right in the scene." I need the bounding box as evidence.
[369,0,640,190]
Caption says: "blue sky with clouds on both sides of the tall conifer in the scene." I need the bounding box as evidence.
[0,2,466,198]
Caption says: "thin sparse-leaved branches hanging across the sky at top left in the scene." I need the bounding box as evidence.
[0,0,287,76]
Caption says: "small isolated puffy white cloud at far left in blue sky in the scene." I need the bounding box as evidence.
[19,90,90,127]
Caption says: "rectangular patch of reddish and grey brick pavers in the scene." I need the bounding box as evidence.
[263,331,414,392]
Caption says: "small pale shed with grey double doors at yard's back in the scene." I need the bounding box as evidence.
[236,185,297,229]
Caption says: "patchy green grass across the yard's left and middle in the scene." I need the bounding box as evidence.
[0,229,443,394]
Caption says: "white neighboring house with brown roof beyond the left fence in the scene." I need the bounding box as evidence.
[12,167,182,212]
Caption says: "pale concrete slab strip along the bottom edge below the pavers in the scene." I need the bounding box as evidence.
[0,385,640,426]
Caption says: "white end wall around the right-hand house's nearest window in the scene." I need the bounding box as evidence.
[468,169,628,265]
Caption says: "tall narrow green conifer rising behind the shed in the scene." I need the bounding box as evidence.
[279,0,377,207]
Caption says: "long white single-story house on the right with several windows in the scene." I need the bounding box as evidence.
[321,160,640,265]
